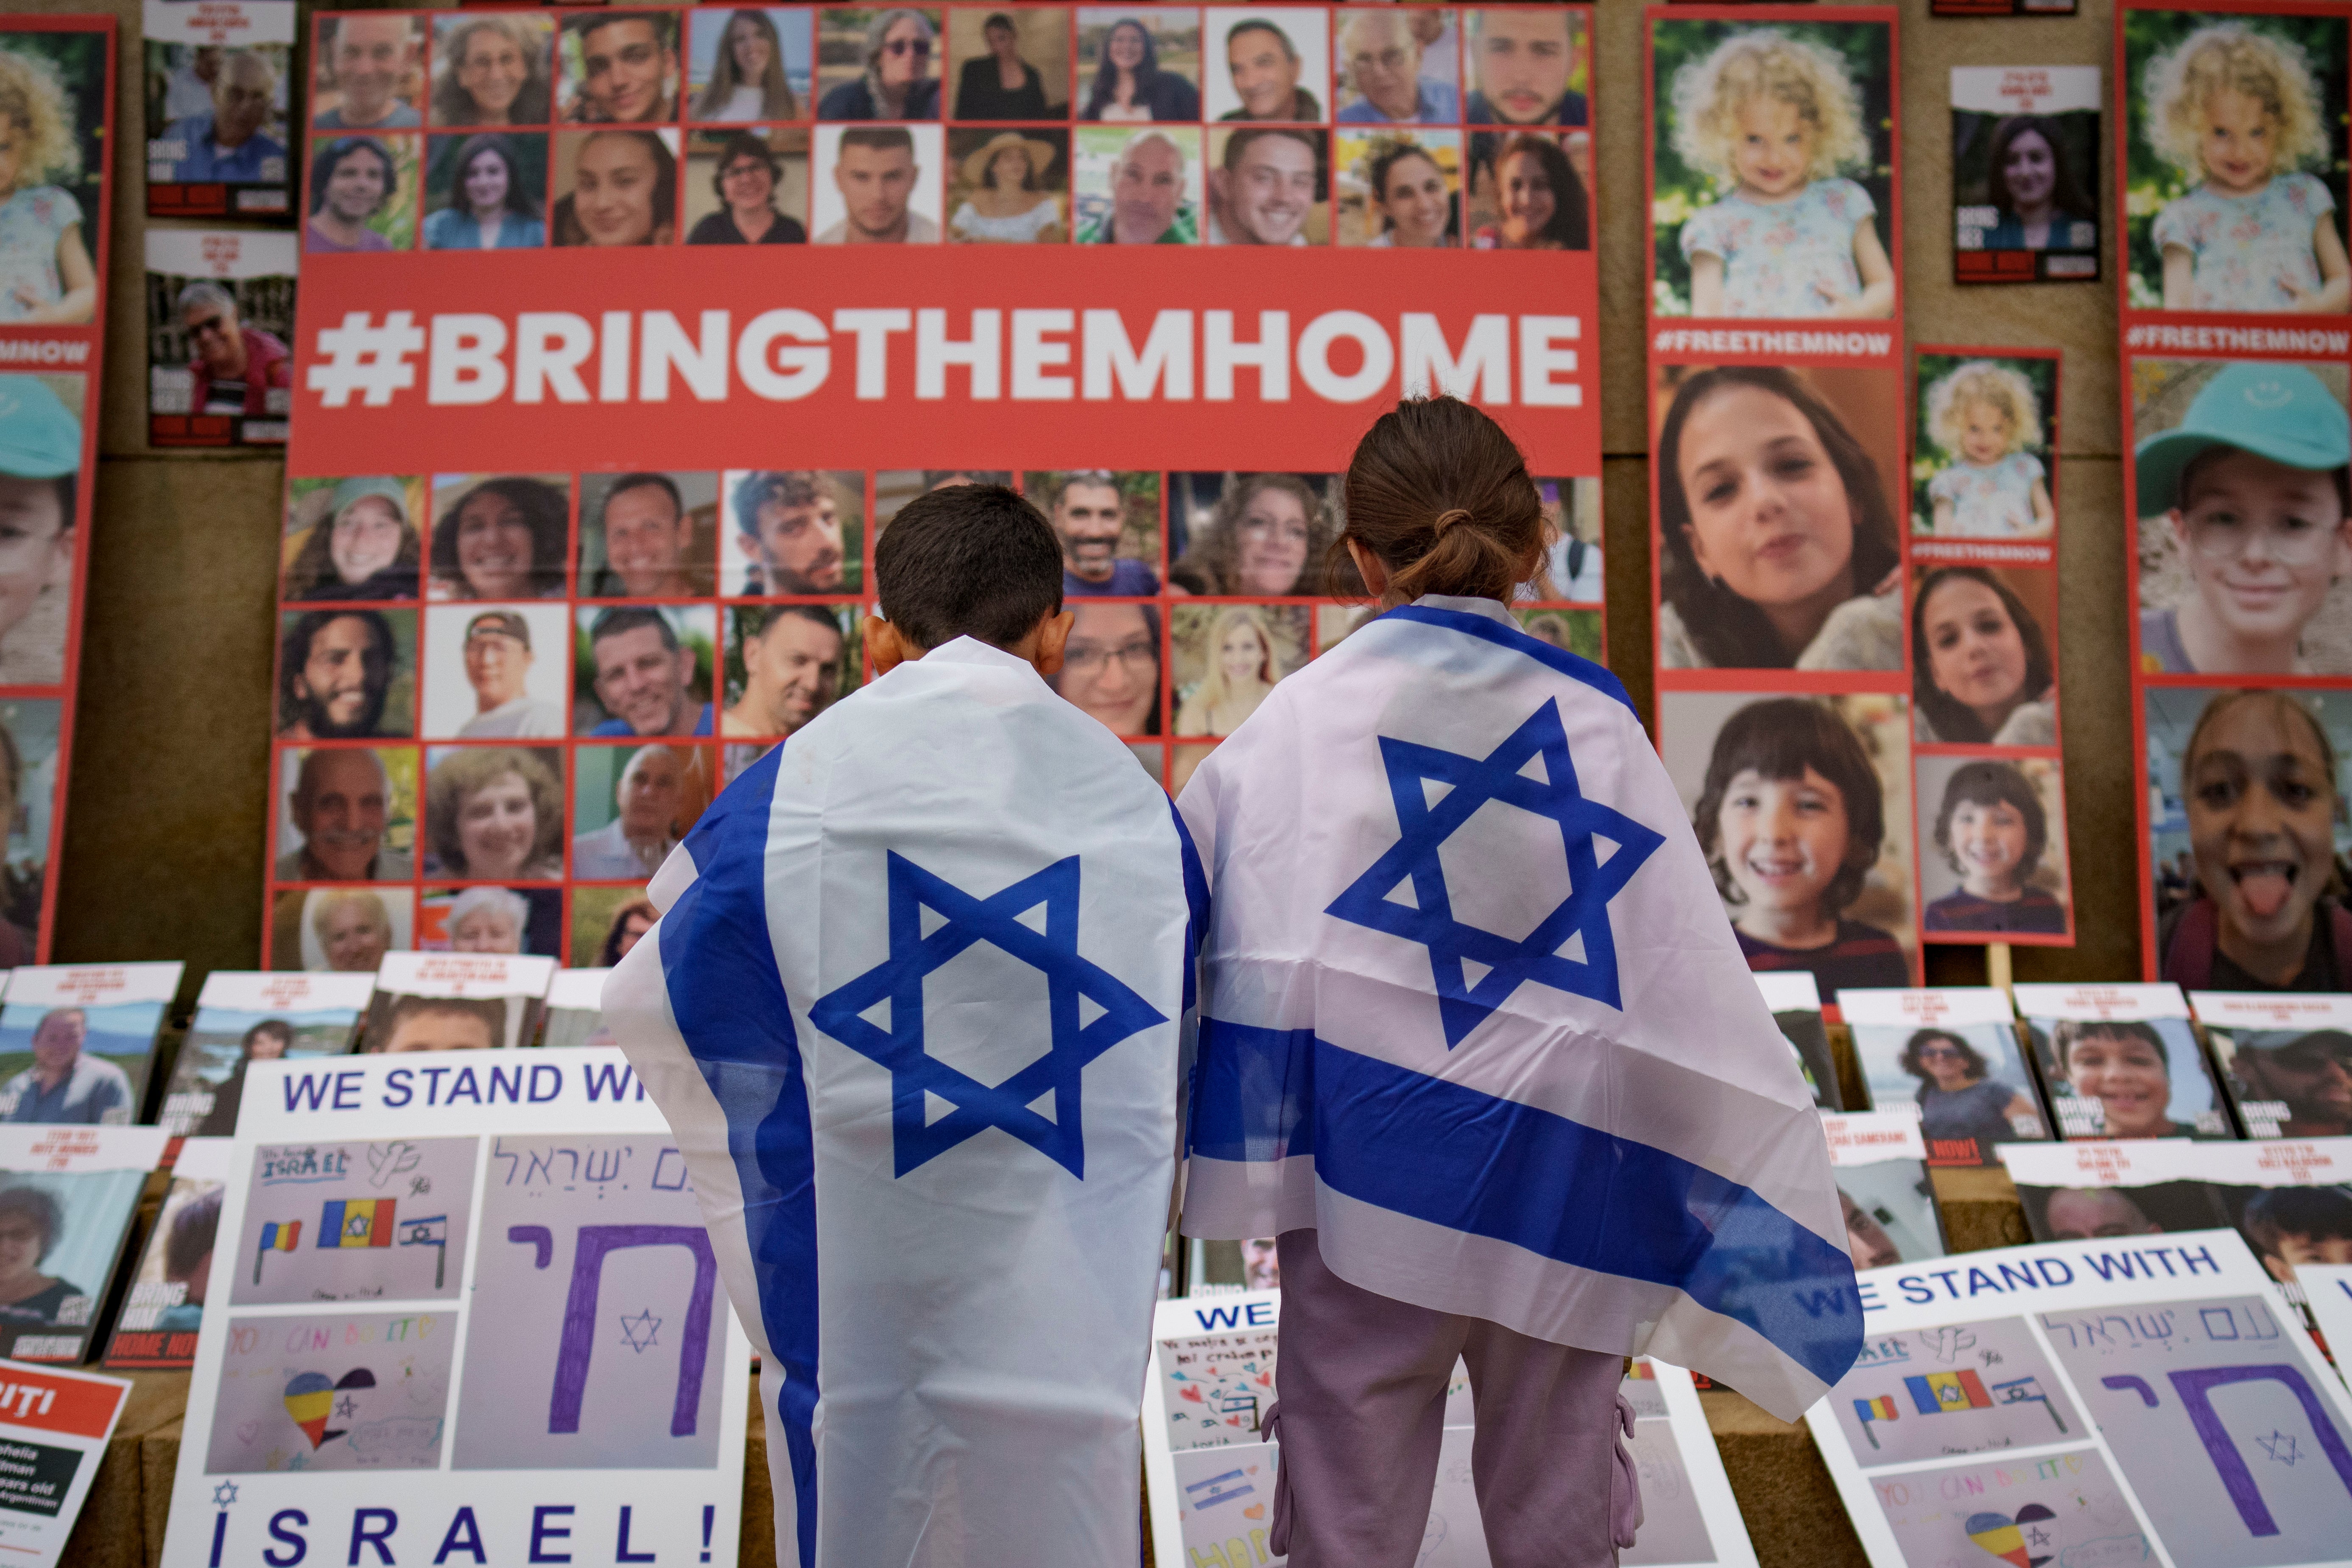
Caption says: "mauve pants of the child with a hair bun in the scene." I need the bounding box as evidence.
[1265,1230,1642,1568]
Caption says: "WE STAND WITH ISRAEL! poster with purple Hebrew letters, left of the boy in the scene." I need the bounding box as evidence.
[162,1051,750,1568]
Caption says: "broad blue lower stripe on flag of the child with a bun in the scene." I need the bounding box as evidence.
[1193,1018,1863,1382]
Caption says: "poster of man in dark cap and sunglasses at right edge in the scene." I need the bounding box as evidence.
[2190,992,2352,1138]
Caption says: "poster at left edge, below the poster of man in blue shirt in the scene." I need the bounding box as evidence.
[0,1126,169,1364]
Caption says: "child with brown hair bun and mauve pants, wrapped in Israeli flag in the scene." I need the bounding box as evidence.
[1179,397,1863,1568]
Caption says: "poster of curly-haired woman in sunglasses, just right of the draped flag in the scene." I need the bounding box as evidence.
[1842,985,2051,1166]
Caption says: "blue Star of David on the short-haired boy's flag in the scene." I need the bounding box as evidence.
[809,851,1164,1180]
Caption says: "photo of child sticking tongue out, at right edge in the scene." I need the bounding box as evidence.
[2142,686,2352,992]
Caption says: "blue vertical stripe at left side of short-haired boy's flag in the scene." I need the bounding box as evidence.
[661,745,816,1568]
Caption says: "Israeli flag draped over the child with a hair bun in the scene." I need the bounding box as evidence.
[1179,595,1863,1420]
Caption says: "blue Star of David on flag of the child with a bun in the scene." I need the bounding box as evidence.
[1324,701,1665,1051]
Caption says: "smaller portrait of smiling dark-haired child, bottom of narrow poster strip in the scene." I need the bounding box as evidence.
[1917,755,2075,943]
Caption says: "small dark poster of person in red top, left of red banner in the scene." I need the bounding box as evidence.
[146,226,299,447]
